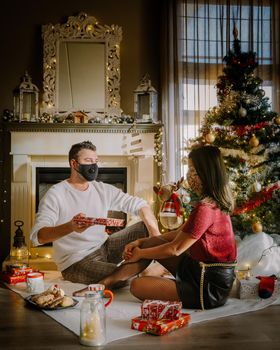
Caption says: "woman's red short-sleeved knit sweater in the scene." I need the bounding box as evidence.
[183,202,236,262]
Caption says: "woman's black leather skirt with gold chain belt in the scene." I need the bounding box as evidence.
[176,254,235,309]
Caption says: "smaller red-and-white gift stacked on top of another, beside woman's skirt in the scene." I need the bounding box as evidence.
[141,299,182,320]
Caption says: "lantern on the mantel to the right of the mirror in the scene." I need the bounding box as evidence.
[134,74,157,123]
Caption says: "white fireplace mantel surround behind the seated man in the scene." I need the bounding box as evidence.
[8,123,161,262]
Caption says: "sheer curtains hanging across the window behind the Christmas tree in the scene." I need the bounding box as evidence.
[161,0,280,182]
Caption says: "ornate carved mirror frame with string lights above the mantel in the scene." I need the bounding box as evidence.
[42,13,122,117]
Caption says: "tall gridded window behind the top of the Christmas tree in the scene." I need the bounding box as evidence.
[180,1,272,129]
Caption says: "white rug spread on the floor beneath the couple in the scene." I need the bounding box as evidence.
[7,271,280,343]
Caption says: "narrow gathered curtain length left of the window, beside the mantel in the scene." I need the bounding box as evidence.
[161,0,183,183]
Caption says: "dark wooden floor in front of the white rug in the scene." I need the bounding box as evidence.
[0,286,280,350]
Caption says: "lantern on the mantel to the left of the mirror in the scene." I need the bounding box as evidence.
[14,72,39,122]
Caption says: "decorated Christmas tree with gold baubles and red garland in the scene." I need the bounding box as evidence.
[189,29,280,237]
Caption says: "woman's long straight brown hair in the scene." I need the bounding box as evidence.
[189,146,234,213]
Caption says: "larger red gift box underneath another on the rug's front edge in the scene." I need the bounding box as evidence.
[131,314,190,335]
